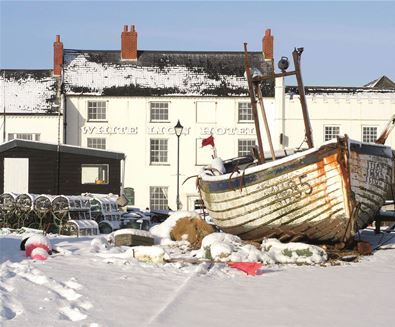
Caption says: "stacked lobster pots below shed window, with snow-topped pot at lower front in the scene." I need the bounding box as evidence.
[57,195,99,235]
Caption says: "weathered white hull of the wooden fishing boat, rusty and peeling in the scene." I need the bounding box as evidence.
[199,138,392,243]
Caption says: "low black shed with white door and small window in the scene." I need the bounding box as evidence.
[0,139,125,195]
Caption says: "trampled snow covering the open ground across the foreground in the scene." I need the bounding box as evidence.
[0,229,395,327]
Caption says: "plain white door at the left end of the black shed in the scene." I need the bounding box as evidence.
[4,158,29,193]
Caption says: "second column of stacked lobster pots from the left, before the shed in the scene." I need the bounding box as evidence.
[13,193,38,228]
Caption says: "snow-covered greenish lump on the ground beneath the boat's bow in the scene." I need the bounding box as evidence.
[262,238,328,264]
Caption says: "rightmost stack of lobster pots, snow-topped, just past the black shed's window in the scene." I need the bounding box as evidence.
[87,193,123,234]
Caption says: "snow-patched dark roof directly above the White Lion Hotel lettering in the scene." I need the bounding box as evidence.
[64,49,274,96]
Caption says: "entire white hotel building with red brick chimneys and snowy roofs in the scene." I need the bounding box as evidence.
[0,26,395,210]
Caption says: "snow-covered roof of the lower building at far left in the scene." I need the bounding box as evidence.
[0,69,60,114]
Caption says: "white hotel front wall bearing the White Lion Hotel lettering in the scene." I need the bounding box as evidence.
[67,96,275,210]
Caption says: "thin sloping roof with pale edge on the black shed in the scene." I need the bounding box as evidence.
[0,139,125,160]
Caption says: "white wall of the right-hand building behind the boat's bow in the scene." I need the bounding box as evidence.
[274,82,395,148]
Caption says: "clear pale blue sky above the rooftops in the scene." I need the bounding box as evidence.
[0,0,395,86]
